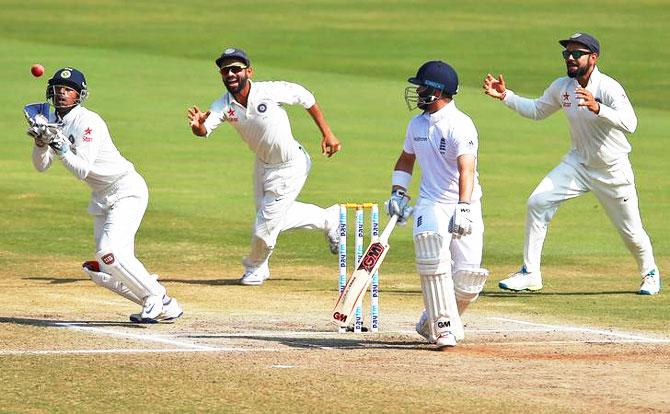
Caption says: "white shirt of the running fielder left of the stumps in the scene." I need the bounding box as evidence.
[205,81,316,164]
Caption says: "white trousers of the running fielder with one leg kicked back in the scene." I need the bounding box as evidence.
[243,148,327,271]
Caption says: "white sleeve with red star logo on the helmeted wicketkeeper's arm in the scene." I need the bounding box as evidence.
[61,117,107,180]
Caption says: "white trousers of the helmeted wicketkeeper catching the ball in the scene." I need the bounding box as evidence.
[88,171,165,298]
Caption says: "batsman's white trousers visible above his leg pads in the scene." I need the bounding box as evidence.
[414,199,484,272]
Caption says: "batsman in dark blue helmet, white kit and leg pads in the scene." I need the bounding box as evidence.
[387,61,488,349]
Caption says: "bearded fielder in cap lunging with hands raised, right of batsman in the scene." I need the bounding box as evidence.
[483,33,661,295]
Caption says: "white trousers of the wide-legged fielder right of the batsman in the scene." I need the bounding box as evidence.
[523,153,656,275]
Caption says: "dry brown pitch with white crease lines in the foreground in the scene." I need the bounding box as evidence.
[0,264,670,413]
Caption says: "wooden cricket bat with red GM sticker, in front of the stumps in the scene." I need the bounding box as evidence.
[331,216,398,327]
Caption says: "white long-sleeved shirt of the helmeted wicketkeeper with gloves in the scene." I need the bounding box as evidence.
[33,105,135,191]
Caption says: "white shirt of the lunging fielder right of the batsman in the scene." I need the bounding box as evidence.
[503,67,637,168]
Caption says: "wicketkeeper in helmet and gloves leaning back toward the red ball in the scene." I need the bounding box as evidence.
[26,68,182,323]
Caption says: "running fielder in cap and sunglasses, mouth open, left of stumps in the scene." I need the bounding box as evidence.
[188,48,342,285]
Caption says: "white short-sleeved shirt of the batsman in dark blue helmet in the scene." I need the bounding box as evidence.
[403,101,482,203]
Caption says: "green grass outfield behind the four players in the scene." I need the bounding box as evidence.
[0,0,670,410]
